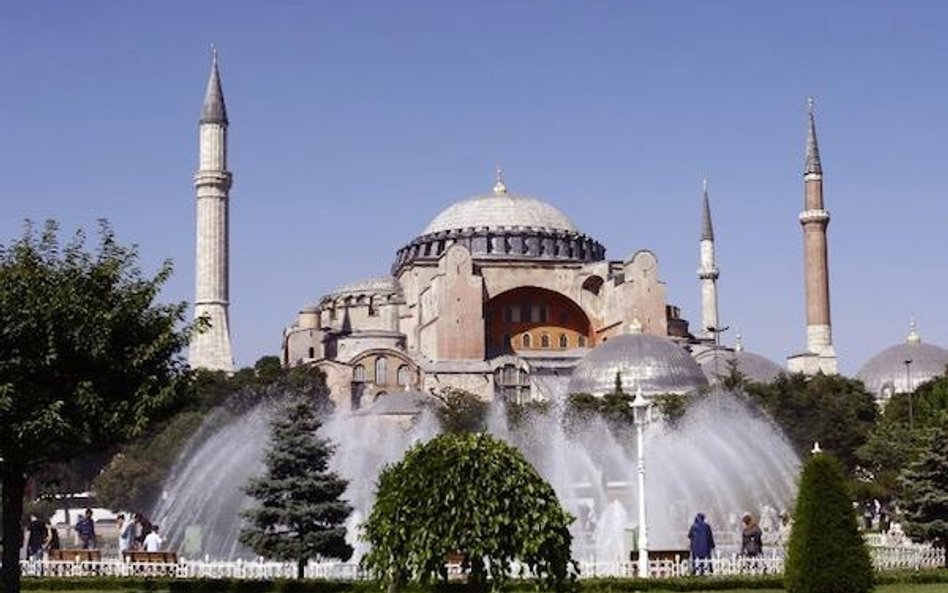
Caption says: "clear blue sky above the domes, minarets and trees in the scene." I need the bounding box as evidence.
[0,0,948,373]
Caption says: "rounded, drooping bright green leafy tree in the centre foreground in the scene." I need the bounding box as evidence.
[363,434,575,588]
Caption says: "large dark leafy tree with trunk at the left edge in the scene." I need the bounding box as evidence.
[0,222,189,593]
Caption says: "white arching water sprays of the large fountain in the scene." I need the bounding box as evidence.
[153,393,799,561]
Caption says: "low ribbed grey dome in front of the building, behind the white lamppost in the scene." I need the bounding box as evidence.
[568,333,708,395]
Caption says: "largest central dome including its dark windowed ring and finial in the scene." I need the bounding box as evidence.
[392,171,606,277]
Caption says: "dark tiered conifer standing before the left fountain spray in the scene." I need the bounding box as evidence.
[240,396,352,578]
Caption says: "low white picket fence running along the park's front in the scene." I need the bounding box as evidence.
[20,544,945,581]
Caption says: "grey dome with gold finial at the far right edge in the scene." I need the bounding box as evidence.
[856,321,948,399]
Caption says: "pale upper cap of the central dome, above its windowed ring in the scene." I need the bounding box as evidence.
[422,178,579,235]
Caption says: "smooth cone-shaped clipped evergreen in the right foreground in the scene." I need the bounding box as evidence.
[784,454,873,593]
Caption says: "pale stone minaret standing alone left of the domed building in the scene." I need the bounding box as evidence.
[189,50,234,372]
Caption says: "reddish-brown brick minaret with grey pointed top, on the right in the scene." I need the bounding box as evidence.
[788,99,837,374]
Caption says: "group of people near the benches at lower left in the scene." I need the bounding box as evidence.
[26,509,164,560]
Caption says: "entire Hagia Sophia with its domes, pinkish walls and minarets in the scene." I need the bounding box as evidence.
[189,54,948,410]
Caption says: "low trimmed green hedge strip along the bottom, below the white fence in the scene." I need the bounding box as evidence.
[22,569,948,593]
